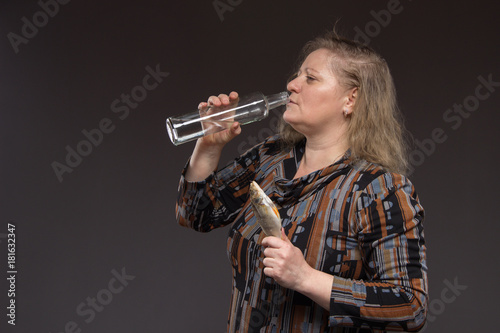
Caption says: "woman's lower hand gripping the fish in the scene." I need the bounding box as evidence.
[262,228,313,290]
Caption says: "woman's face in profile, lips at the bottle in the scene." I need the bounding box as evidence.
[283,49,353,137]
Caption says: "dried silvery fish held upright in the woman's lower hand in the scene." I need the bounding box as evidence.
[250,181,281,238]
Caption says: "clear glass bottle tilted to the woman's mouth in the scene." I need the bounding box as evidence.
[166,92,290,146]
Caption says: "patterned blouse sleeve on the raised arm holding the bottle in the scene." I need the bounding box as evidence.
[175,146,259,232]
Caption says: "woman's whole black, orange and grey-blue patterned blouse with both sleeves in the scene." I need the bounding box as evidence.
[176,136,427,333]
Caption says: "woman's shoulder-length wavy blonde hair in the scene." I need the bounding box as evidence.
[279,31,409,174]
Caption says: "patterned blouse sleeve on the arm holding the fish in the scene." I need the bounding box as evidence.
[330,173,428,331]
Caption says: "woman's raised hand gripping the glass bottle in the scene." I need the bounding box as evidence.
[197,91,241,149]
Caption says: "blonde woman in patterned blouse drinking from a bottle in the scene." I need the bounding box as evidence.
[176,29,427,332]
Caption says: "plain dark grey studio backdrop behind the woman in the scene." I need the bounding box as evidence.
[0,0,500,333]
